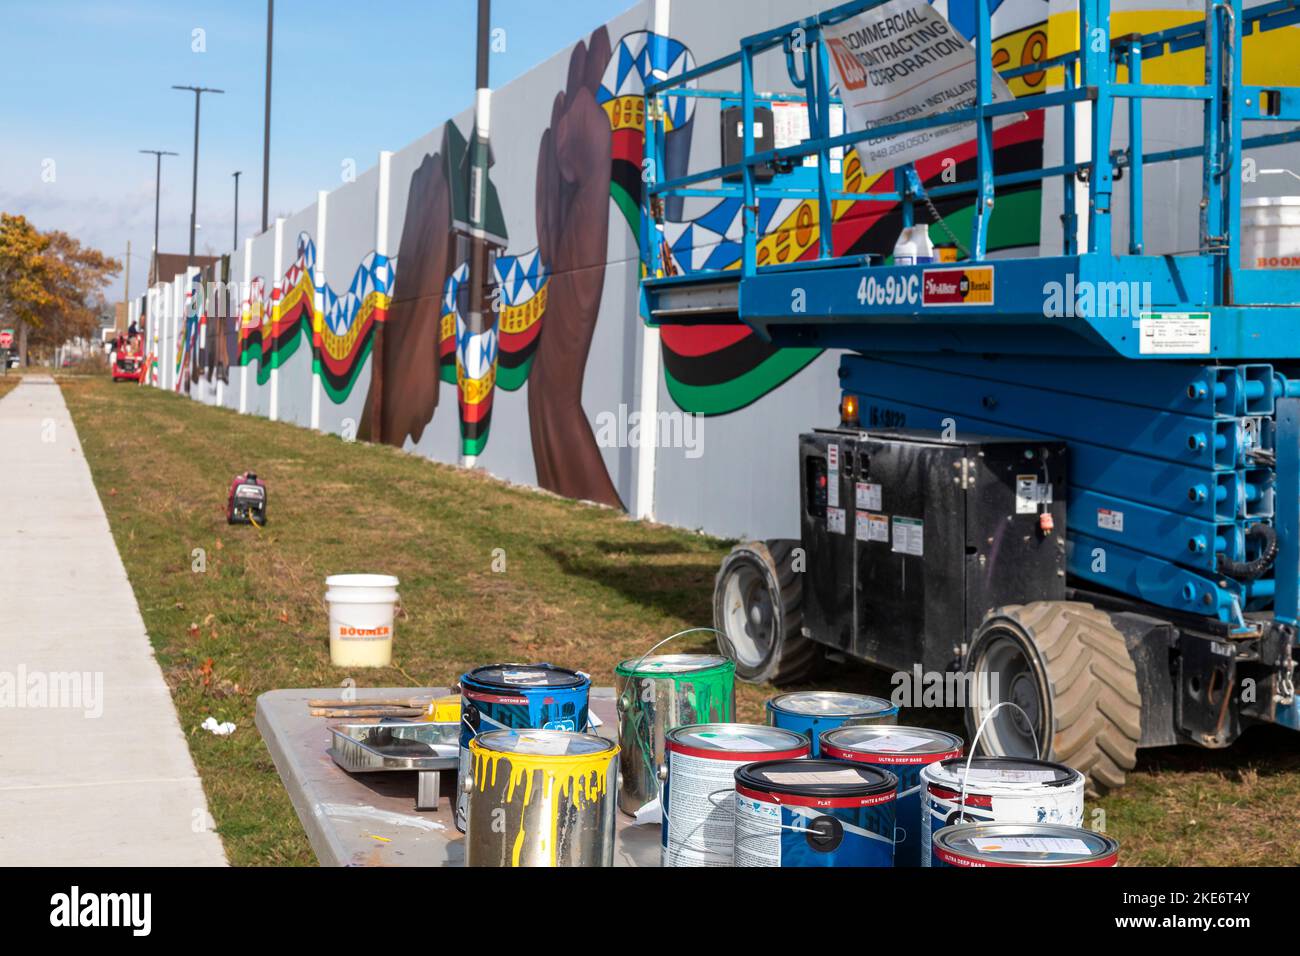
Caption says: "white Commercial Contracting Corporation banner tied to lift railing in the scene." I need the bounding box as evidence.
[824,0,1024,174]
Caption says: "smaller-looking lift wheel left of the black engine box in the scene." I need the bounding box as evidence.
[714,538,823,684]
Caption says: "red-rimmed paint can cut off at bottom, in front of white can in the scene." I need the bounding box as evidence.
[930,823,1119,866]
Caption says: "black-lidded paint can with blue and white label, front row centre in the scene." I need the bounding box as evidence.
[735,760,898,866]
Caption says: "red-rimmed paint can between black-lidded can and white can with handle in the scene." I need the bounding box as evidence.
[822,726,963,866]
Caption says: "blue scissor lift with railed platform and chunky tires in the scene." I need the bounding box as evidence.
[641,0,1300,790]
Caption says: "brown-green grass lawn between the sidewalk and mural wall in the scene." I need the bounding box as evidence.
[60,376,1300,865]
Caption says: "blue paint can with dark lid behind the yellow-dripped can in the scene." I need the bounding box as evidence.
[456,663,592,832]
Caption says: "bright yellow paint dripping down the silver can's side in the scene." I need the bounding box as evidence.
[469,740,619,866]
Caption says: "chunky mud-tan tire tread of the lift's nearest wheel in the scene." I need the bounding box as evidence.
[963,601,1141,797]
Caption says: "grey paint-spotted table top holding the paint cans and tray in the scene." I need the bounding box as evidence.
[257,687,659,866]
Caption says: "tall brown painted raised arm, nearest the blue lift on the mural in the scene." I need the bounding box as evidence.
[528,27,623,507]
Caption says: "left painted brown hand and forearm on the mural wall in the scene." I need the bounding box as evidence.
[358,140,455,447]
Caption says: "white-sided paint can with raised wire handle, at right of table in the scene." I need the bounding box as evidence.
[920,757,1084,866]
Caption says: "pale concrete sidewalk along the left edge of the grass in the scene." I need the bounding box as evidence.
[0,376,226,866]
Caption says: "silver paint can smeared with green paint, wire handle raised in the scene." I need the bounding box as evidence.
[614,654,736,814]
